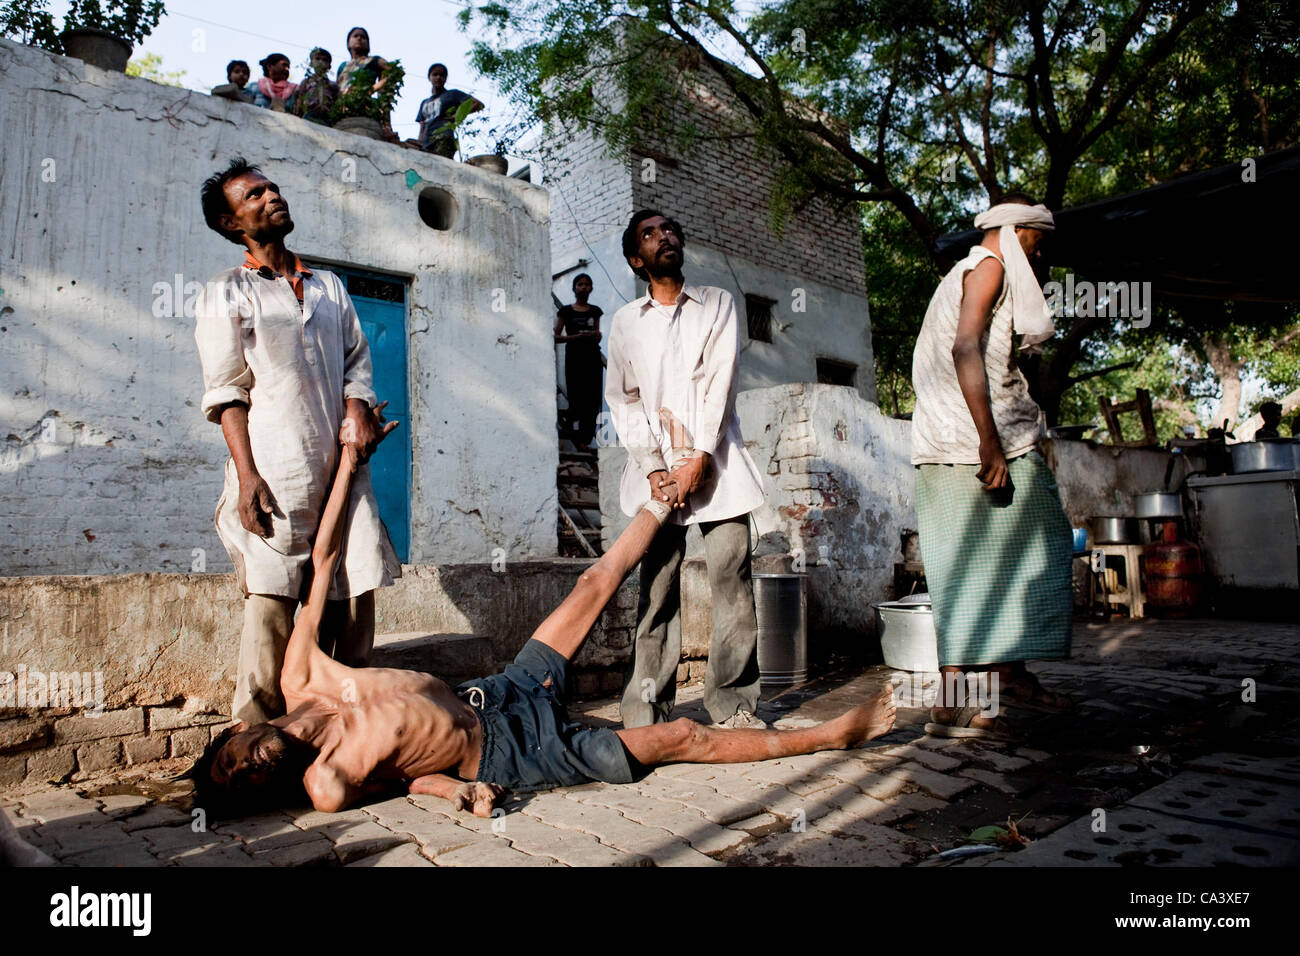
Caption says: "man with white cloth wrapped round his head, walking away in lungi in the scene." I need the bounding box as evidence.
[911,194,1071,739]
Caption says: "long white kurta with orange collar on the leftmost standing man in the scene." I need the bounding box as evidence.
[195,267,402,600]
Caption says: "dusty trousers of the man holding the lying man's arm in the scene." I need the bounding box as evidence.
[230,591,374,723]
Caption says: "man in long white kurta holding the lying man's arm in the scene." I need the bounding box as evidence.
[195,164,400,722]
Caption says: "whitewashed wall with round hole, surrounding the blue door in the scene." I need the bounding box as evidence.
[0,40,556,575]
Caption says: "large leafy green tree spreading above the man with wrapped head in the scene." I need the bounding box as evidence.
[463,0,1300,420]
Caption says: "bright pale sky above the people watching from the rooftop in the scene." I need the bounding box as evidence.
[49,0,501,147]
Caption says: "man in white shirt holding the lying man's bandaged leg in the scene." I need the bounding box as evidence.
[606,209,766,728]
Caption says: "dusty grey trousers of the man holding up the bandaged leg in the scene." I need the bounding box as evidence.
[623,515,759,727]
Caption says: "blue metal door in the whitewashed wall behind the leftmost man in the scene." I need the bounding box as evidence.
[325,265,411,563]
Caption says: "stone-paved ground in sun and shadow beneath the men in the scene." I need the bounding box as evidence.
[0,620,1300,866]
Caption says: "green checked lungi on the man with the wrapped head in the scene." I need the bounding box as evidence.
[917,451,1073,667]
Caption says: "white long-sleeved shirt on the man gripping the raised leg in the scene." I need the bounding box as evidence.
[605,285,763,524]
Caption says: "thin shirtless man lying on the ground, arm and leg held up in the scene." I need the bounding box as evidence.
[191,423,894,817]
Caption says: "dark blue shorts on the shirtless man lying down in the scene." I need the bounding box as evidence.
[456,640,633,792]
